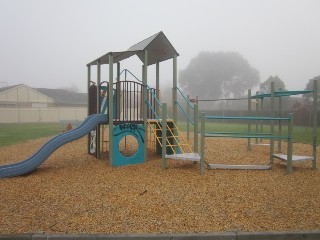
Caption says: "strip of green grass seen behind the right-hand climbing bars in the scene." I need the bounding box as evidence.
[178,122,320,144]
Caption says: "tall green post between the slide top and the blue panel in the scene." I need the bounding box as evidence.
[108,53,113,166]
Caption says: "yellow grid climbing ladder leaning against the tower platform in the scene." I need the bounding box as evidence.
[148,119,192,154]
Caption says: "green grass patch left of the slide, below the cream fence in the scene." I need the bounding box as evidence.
[0,123,66,147]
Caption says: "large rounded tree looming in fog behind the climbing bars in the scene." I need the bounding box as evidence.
[179,52,259,99]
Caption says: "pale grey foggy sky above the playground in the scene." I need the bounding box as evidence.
[0,0,320,92]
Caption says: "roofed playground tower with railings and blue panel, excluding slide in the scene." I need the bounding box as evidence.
[87,32,200,171]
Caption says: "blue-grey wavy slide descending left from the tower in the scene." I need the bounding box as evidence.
[0,114,107,178]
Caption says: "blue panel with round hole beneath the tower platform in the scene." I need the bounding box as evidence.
[112,123,145,166]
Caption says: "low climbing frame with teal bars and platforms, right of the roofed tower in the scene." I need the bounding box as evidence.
[187,80,318,173]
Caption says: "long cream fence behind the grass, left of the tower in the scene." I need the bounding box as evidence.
[0,107,87,123]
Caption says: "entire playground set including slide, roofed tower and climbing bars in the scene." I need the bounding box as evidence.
[0,32,317,178]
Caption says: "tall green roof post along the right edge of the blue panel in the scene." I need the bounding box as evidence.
[142,50,148,162]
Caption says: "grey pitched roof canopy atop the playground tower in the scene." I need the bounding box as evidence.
[87,32,179,66]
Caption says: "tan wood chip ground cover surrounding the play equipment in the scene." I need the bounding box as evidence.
[0,138,320,234]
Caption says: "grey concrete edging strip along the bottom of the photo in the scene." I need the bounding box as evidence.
[0,231,320,240]
